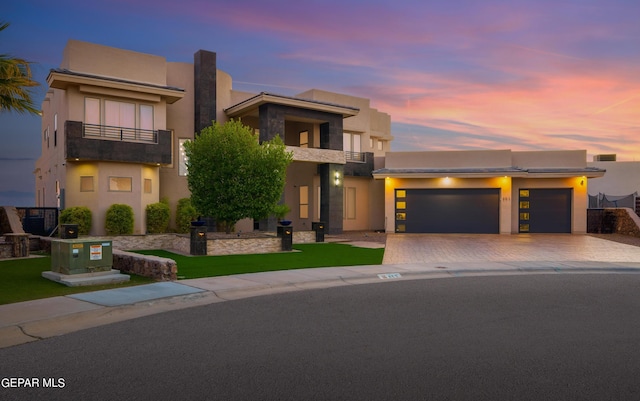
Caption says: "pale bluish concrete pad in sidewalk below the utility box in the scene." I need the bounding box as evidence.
[68,282,203,306]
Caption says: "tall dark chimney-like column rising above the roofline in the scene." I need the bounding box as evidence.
[193,50,217,132]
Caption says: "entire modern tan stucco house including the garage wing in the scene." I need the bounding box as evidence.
[35,40,605,235]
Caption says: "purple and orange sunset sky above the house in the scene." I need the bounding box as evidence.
[0,0,640,206]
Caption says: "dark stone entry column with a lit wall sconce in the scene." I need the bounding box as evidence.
[318,163,344,234]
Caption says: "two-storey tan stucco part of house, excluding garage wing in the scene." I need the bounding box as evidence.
[34,40,393,234]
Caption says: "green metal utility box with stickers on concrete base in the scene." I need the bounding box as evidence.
[51,239,113,275]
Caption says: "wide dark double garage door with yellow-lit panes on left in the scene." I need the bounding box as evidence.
[396,188,500,234]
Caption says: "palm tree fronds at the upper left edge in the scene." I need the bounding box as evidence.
[0,22,40,114]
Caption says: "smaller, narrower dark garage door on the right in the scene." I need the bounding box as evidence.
[519,188,571,233]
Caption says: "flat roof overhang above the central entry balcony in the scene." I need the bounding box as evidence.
[224,92,360,118]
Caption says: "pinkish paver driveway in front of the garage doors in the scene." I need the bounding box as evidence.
[383,234,640,264]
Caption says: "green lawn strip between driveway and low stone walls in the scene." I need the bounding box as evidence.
[134,243,384,279]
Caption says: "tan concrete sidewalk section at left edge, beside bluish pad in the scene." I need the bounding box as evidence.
[0,297,102,327]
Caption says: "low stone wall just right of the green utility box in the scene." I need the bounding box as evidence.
[113,249,178,281]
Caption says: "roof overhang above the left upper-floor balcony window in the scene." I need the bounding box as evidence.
[47,69,184,104]
